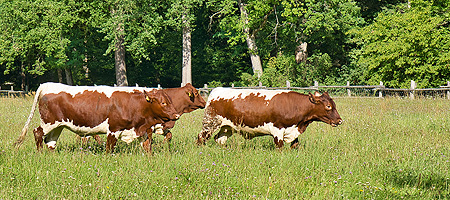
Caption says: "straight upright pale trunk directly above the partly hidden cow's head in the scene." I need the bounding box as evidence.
[181,10,192,86]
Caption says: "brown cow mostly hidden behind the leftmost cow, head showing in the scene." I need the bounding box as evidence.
[89,83,206,144]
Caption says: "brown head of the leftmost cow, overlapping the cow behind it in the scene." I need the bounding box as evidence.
[144,90,180,121]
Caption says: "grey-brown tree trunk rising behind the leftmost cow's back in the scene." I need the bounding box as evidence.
[111,8,128,86]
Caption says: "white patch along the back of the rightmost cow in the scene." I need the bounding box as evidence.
[206,87,290,106]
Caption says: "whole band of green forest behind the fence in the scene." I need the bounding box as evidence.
[0,0,450,90]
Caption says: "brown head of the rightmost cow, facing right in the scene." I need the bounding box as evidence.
[309,91,343,127]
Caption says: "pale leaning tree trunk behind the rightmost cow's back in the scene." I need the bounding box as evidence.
[238,0,263,78]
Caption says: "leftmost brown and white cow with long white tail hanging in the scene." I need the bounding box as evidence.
[16,83,179,153]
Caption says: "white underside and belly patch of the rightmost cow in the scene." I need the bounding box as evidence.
[218,116,300,144]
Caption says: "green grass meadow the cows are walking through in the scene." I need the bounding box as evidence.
[0,98,450,199]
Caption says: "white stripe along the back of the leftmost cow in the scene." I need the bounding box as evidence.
[40,83,153,98]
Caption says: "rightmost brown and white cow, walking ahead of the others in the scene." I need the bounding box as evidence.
[197,88,342,148]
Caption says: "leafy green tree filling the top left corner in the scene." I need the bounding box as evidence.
[0,0,75,90]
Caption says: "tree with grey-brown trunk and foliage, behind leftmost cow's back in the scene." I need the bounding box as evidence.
[91,0,163,86]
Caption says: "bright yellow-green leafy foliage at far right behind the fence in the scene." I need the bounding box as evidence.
[351,1,450,88]
